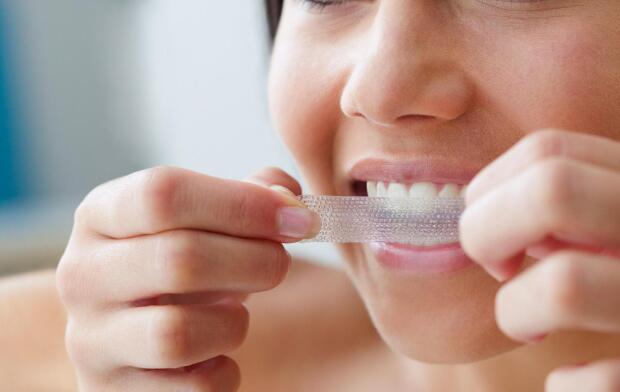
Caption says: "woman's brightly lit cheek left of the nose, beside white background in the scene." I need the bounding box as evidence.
[269,38,341,191]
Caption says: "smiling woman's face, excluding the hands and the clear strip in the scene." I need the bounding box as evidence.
[270,0,620,363]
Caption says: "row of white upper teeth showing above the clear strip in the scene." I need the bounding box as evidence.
[366,181,467,198]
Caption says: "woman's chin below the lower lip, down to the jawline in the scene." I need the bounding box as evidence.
[343,245,520,364]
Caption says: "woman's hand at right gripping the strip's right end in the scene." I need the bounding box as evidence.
[460,130,620,392]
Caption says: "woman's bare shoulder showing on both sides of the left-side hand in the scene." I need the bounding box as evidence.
[0,260,377,391]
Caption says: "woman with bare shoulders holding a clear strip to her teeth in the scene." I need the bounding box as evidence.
[3,0,620,391]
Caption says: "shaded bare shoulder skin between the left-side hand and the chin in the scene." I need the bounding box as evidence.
[233,259,378,391]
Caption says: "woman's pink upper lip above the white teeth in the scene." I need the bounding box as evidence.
[347,157,482,185]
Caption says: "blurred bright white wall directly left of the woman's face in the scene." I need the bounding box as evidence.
[133,0,337,262]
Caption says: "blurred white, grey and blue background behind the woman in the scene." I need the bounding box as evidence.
[0,0,337,275]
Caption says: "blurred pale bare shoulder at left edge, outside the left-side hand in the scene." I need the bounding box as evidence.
[0,270,75,391]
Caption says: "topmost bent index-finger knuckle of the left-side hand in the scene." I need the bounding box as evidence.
[141,166,181,226]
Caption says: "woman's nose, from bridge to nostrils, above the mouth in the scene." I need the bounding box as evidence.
[340,1,472,128]
